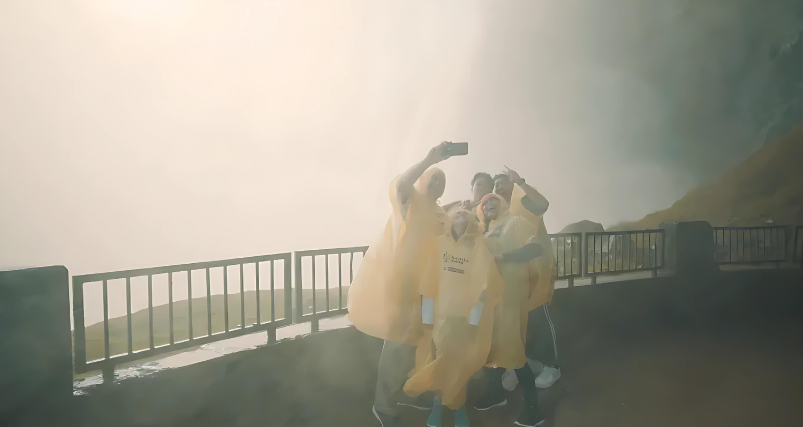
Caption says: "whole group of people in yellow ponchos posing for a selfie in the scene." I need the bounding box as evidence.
[349,142,560,427]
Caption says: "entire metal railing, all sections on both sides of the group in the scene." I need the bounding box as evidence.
[72,227,803,379]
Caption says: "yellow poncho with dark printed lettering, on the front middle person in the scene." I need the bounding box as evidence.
[404,210,502,409]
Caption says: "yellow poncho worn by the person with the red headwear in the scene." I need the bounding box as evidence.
[477,194,535,369]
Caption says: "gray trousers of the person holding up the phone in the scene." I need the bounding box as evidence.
[374,341,415,416]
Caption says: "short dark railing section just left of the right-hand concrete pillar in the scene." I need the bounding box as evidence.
[584,230,666,283]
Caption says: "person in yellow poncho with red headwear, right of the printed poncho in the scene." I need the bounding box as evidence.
[475,194,544,427]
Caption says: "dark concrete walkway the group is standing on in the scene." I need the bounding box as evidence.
[51,310,803,427]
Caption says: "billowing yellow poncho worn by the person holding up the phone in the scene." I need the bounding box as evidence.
[348,168,446,345]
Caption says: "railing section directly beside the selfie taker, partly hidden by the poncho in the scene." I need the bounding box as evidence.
[294,246,368,332]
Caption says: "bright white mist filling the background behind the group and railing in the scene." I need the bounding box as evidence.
[0,0,801,274]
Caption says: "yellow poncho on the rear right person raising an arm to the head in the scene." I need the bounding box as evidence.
[510,185,557,310]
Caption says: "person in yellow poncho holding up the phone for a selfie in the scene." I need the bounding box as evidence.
[348,143,458,427]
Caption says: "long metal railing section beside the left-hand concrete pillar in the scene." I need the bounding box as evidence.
[72,253,292,378]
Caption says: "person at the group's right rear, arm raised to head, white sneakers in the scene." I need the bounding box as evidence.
[494,169,560,388]
